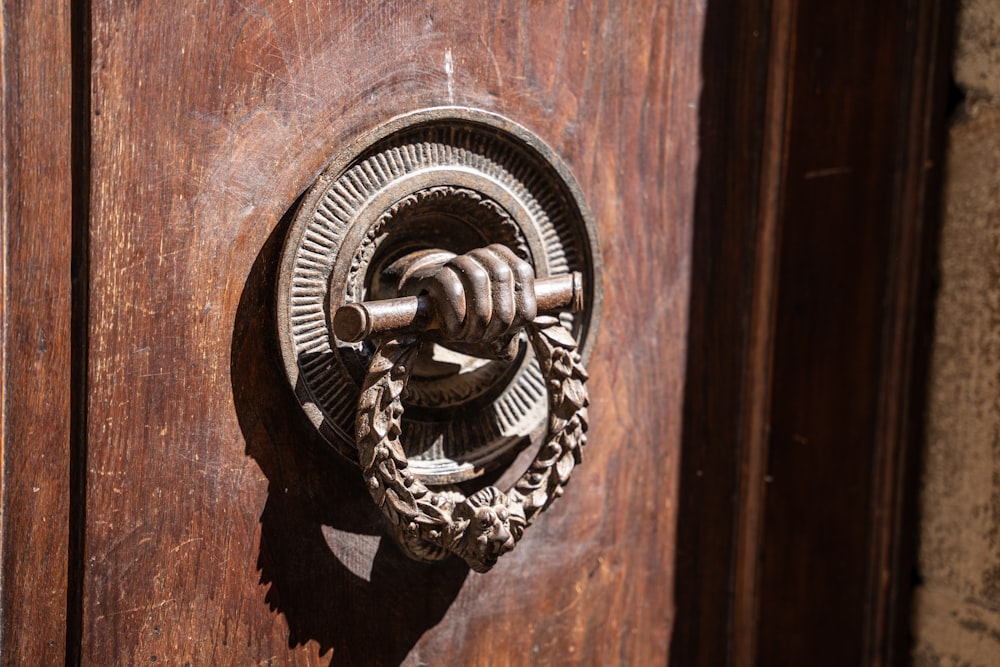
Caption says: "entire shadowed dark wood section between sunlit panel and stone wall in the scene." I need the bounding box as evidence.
[672,2,953,666]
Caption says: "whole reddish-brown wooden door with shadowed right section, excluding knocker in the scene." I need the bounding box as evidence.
[0,0,949,665]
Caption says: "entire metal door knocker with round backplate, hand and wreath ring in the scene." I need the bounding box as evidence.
[277,108,601,572]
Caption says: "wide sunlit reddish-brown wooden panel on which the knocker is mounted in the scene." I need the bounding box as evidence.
[82,0,702,665]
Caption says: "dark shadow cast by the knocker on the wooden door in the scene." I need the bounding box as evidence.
[230,203,469,665]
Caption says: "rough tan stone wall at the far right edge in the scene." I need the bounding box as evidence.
[913,0,1000,667]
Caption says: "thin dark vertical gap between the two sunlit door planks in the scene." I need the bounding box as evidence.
[66,0,92,665]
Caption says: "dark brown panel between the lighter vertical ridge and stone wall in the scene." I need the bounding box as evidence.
[759,2,952,665]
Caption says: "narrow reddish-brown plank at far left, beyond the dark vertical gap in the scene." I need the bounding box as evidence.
[0,2,72,665]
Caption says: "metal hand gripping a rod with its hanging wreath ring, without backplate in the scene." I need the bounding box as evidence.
[334,245,588,572]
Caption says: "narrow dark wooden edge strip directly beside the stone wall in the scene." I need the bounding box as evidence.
[862,0,957,666]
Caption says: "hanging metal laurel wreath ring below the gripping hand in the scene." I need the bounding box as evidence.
[355,317,589,572]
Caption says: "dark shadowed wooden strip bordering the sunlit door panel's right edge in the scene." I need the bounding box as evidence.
[670,2,784,667]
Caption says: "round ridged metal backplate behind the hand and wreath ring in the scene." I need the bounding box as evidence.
[277,107,601,484]
